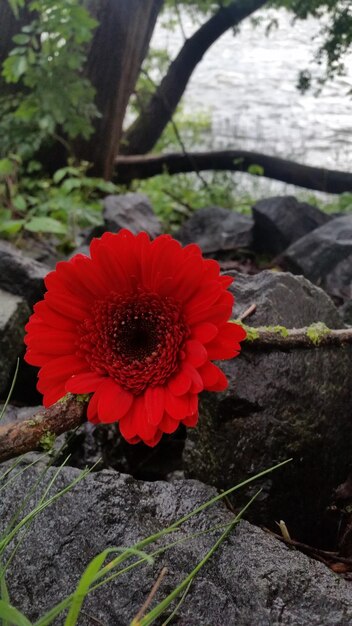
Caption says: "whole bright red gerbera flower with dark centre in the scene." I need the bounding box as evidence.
[25,230,246,446]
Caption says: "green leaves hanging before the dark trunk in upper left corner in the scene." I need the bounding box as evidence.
[0,0,97,158]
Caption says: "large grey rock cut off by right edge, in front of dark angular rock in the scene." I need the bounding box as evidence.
[280,215,352,300]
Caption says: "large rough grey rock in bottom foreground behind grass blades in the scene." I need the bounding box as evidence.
[0,467,352,626]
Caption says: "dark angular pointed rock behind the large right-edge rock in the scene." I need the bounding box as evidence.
[252,196,331,256]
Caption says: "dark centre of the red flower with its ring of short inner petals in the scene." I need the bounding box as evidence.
[77,293,189,395]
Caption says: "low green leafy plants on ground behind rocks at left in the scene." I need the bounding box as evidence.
[0,155,117,245]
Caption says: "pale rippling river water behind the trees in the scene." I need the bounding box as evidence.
[152,10,352,195]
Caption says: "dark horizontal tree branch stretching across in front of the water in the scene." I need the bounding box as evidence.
[113,150,352,194]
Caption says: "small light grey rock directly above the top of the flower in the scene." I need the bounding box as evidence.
[103,193,161,238]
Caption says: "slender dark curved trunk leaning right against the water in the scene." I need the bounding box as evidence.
[120,0,268,154]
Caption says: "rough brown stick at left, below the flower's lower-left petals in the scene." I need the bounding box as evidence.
[0,394,87,463]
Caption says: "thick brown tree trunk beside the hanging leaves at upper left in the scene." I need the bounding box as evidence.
[75,0,164,179]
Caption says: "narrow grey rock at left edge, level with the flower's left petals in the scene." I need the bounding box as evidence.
[0,289,30,394]
